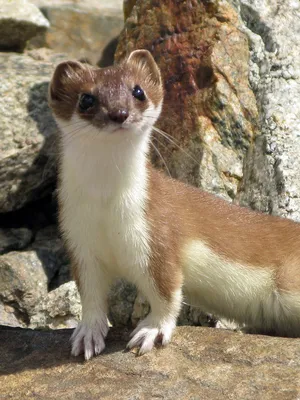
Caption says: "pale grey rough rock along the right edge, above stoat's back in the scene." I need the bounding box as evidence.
[234,0,300,221]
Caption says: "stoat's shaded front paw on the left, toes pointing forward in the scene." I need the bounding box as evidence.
[71,318,108,360]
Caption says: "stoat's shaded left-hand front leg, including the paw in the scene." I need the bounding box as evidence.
[71,260,111,360]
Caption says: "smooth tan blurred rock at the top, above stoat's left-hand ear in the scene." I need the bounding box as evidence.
[31,1,124,66]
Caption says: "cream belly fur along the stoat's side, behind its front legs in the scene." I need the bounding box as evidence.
[182,240,300,336]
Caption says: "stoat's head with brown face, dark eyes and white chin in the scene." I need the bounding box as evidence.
[49,50,163,138]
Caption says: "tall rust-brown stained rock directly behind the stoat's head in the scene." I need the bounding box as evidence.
[116,0,257,200]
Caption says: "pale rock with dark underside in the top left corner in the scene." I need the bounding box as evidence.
[0,0,50,50]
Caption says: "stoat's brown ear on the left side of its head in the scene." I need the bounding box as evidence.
[49,61,86,102]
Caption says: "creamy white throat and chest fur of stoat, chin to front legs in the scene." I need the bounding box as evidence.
[59,117,149,281]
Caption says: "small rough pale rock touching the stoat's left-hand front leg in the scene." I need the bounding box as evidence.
[29,281,81,329]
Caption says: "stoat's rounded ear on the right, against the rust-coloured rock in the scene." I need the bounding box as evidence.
[127,50,162,85]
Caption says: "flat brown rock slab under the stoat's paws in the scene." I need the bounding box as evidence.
[0,327,300,400]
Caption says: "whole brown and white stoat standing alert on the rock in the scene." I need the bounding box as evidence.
[49,50,300,359]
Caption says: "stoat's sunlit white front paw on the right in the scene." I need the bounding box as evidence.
[127,315,176,355]
